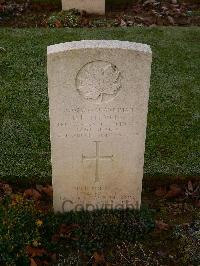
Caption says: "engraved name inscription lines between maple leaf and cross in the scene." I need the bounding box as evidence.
[57,107,137,139]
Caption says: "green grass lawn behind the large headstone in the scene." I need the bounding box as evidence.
[0,27,200,185]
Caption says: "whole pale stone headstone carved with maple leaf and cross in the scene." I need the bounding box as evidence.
[48,41,152,212]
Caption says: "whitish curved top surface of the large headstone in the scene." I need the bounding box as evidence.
[47,40,152,54]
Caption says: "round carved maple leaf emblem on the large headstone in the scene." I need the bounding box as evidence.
[76,61,121,103]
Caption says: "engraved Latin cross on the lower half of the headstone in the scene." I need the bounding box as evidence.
[82,141,113,182]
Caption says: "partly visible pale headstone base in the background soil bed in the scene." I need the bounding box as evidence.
[62,0,105,15]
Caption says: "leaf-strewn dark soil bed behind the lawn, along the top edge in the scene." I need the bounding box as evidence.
[0,0,200,27]
